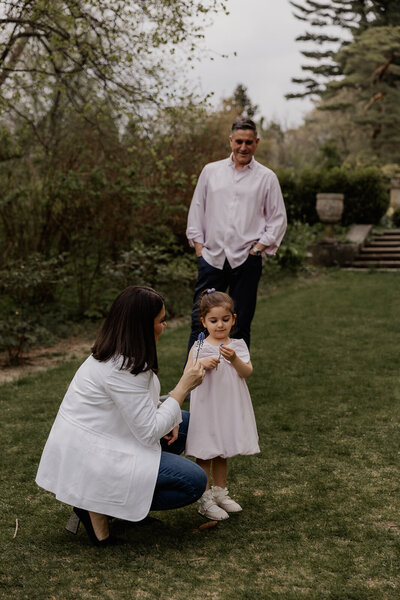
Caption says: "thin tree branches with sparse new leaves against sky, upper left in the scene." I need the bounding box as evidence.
[0,0,225,146]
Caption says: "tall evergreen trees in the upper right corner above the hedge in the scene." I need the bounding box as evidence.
[287,0,400,165]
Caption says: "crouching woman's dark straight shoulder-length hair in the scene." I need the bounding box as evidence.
[92,285,164,375]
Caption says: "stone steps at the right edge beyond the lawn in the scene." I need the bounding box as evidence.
[346,229,400,271]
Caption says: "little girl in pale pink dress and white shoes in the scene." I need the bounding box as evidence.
[185,288,260,521]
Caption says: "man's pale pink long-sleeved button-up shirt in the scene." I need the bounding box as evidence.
[186,155,287,269]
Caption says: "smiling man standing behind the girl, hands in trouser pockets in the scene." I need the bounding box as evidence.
[186,119,287,348]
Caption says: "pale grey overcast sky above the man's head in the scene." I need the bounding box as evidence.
[191,0,318,127]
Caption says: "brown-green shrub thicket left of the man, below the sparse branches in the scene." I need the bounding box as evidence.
[0,99,238,360]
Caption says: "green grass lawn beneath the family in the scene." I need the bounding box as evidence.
[0,272,400,600]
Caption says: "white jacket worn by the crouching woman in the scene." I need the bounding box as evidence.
[36,356,182,521]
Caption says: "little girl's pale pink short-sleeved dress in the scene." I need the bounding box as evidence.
[185,339,260,460]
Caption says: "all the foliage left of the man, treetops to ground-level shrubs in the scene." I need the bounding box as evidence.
[0,0,230,361]
